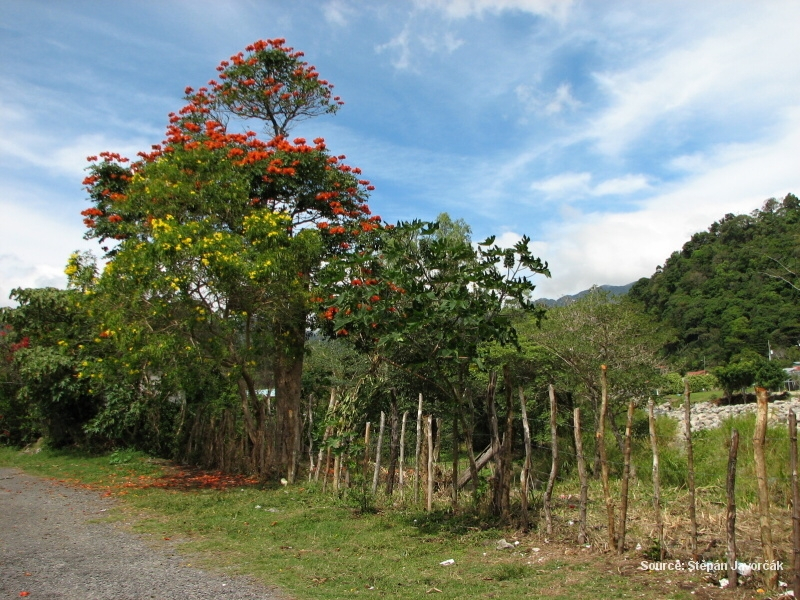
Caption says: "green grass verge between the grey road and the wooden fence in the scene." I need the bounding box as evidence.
[0,448,708,599]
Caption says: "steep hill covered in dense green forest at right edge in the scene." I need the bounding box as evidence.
[629,194,800,369]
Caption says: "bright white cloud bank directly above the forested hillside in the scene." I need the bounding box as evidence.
[537,109,800,297]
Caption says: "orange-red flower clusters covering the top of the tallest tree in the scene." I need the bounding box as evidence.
[83,38,381,244]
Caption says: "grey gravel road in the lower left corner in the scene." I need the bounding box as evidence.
[0,468,281,600]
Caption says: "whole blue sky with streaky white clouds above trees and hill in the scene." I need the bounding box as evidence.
[0,0,800,305]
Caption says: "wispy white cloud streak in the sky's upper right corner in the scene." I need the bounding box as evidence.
[586,3,800,155]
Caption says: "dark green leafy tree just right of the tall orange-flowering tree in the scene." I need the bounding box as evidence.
[323,221,549,512]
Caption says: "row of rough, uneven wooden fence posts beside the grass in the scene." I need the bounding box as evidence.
[309,365,800,598]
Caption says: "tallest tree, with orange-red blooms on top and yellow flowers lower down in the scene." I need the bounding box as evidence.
[83,39,380,480]
